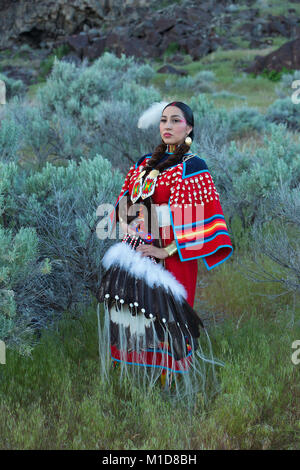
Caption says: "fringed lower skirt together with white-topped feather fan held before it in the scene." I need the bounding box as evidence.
[97,235,222,397]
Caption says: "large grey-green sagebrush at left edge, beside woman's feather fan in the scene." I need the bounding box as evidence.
[0,155,122,350]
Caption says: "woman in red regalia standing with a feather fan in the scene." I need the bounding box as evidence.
[98,102,233,398]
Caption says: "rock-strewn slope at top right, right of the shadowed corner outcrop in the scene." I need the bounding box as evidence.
[58,0,300,60]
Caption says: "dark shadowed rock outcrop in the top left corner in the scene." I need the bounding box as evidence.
[0,0,146,49]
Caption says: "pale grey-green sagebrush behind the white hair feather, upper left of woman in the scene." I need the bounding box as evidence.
[0,53,161,172]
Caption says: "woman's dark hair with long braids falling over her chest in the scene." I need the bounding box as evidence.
[119,101,194,252]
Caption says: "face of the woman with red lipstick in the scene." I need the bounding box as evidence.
[159,106,193,145]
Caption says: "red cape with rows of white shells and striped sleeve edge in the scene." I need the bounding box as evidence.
[110,154,233,270]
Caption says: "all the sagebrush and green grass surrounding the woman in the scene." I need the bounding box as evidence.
[0,21,300,450]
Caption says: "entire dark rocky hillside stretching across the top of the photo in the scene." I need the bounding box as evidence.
[0,0,300,84]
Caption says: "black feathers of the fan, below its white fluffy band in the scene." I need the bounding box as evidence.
[97,238,204,360]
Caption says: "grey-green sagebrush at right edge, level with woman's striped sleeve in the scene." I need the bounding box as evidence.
[202,124,300,235]
